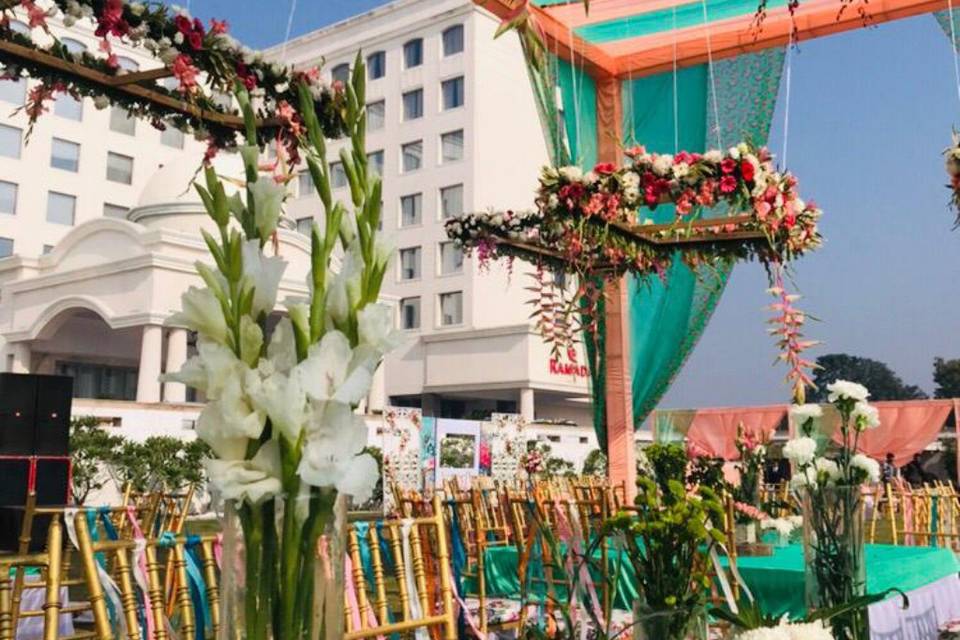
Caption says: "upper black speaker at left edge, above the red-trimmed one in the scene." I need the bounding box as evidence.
[0,373,73,456]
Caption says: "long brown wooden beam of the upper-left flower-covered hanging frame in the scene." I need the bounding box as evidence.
[0,40,281,130]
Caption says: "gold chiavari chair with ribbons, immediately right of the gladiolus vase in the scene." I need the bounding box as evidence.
[344,494,457,640]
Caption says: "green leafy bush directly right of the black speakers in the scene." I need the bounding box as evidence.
[70,416,123,504]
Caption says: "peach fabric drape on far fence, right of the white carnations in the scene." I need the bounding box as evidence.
[824,400,954,466]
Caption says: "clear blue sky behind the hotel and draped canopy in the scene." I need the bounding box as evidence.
[180,0,960,407]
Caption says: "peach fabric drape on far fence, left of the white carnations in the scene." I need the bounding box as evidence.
[687,405,787,460]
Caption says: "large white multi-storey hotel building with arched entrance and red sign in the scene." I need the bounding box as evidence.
[0,0,590,444]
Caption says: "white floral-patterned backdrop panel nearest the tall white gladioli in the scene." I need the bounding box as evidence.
[381,407,435,514]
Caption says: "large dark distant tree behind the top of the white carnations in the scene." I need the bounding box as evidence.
[807,353,927,402]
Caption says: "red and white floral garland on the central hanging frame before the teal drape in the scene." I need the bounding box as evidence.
[446,143,821,348]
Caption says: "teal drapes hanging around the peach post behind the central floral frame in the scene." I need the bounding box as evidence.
[552,49,783,449]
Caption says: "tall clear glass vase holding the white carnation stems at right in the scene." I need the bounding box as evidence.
[803,485,870,640]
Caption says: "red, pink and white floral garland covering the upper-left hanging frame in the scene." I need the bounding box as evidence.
[0,0,346,154]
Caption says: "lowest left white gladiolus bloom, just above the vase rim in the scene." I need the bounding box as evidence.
[204,440,282,504]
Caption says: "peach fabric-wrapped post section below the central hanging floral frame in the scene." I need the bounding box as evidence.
[604,278,637,504]
